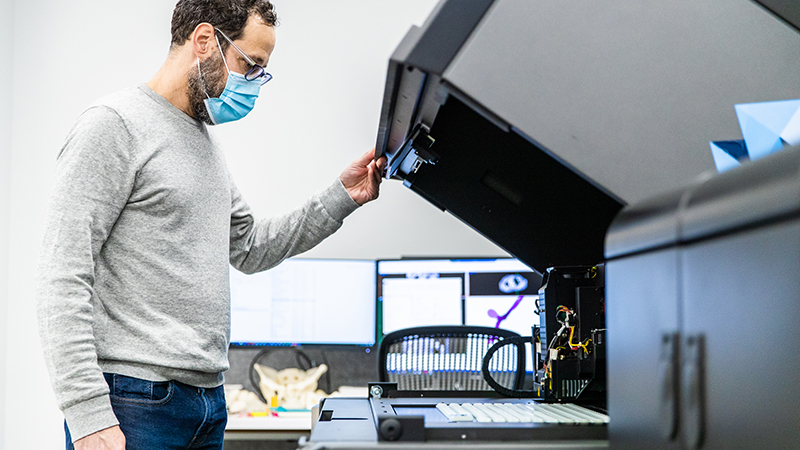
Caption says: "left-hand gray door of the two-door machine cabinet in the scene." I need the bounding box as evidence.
[606,249,678,449]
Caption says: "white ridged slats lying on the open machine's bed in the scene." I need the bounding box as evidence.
[436,401,608,425]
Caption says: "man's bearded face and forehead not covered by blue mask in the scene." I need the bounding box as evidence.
[189,15,275,125]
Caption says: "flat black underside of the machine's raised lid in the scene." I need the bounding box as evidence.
[407,96,622,271]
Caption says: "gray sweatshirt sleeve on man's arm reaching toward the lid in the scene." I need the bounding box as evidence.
[230,178,358,273]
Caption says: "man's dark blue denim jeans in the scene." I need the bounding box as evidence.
[64,373,228,450]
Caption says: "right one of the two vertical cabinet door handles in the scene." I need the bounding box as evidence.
[681,335,706,450]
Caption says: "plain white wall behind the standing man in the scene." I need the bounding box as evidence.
[0,0,505,450]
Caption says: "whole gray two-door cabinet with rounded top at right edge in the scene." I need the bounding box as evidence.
[606,148,800,449]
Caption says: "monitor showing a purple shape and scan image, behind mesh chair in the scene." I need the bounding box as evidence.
[377,258,542,336]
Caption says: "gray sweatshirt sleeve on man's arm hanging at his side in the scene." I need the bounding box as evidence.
[36,106,136,440]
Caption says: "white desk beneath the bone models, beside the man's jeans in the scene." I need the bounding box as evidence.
[225,412,311,450]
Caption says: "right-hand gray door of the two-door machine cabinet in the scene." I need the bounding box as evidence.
[681,220,800,449]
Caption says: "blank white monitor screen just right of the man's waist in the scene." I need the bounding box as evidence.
[231,258,376,346]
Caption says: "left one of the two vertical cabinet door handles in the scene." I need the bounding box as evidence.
[659,333,680,441]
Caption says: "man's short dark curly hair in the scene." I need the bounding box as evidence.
[171,0,278,47]
